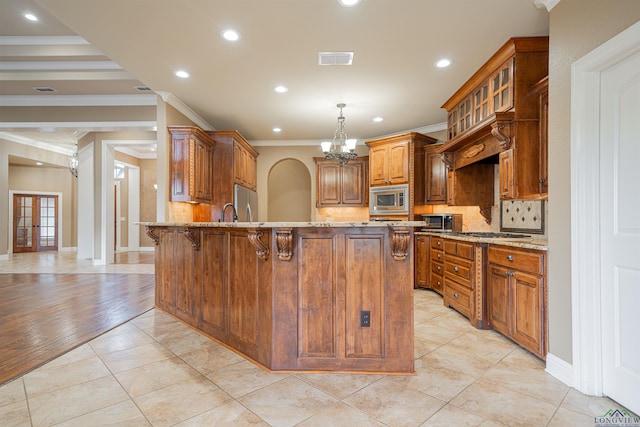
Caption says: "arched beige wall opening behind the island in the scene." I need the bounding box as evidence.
[267,159,311,222]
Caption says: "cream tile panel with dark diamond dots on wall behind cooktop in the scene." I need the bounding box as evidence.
[500,200,544,234]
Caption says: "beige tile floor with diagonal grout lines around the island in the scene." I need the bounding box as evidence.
[0,254,636,427]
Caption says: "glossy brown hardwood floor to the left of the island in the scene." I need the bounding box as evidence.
[0,254,154,384]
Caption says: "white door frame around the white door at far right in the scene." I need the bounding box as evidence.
[571,22,640,396]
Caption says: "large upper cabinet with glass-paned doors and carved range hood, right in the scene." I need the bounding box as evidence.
[439,37,549,206]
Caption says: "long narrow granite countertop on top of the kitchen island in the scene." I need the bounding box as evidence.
[142,221,425,228]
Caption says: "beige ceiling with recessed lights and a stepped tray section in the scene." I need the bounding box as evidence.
[0,0,549,156]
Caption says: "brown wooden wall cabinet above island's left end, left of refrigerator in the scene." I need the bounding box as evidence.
[168,126,215,203]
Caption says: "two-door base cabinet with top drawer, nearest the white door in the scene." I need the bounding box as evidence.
[487,245,547,359]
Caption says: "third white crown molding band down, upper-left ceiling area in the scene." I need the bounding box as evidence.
[0,94,158,107]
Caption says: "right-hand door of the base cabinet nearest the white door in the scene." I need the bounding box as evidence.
[511,270,546,357]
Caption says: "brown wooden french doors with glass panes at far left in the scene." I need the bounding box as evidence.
[13,194,58,253]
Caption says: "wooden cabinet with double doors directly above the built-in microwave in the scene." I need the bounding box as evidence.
[366,132,438,218]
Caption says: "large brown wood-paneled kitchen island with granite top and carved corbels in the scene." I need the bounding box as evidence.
[141,221,424,373]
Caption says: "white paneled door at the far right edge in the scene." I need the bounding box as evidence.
[600,53,640,413]
